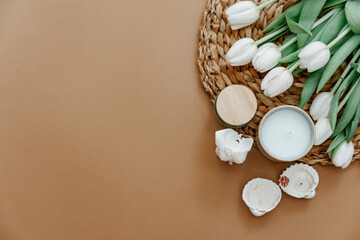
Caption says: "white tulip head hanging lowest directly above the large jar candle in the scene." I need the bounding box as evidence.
[261,67,294,97]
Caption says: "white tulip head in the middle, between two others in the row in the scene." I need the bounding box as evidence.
[252,43,281,73]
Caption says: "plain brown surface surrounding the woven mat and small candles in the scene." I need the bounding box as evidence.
[0,0,360,240]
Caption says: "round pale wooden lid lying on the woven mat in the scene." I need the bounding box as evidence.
[215,85,257,127]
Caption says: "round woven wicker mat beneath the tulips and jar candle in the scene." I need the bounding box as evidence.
[198,0,360,165]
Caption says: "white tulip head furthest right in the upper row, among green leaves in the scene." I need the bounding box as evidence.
[298,41,330,72]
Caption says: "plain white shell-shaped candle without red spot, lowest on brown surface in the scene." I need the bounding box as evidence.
[242,178,281,217]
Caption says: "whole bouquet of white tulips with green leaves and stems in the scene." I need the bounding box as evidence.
[226,0,360,168]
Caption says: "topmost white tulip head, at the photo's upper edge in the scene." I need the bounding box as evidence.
[226,1,259,30]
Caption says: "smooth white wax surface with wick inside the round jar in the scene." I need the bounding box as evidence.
[260,109,312,160]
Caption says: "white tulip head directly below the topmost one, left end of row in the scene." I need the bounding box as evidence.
[226,38,257,66]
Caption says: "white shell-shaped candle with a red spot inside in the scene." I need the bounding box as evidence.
[279,163,319,199]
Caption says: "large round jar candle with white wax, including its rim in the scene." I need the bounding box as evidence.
[257,105,315,162]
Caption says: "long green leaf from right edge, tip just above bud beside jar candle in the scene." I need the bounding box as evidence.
[317,34,360,92]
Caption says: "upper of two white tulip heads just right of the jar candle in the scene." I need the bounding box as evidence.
[310,92,334,121]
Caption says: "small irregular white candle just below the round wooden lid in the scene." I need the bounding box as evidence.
[215,128,254,165]
